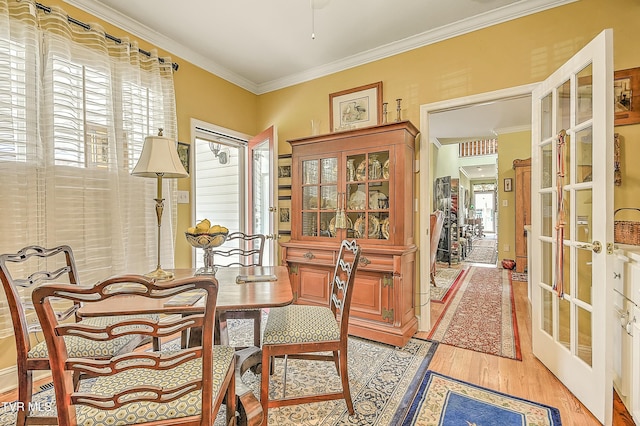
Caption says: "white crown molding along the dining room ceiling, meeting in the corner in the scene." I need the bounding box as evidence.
[64,0,578,95]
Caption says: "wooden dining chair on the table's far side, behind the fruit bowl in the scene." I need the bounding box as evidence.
[212,231,266,347]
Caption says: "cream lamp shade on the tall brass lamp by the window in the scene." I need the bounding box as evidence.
[131,136,189,178]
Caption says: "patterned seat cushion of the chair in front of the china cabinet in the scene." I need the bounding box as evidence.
[262,305,340,345]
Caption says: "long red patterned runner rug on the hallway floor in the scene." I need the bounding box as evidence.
[429,266,522,360]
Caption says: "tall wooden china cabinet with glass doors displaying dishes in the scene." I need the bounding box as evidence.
[281,121,418,346]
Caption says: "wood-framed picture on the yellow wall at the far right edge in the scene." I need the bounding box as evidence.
[613,67,640,126]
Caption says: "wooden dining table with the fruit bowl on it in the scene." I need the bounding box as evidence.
[78,266,293,425]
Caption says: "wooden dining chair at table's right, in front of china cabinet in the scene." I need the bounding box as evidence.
[260,240,360,419]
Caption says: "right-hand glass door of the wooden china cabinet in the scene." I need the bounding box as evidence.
[345,151,392,240]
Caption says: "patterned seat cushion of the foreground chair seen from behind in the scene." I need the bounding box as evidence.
[75,346,235,426]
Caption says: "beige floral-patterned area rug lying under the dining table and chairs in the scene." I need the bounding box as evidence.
[0,320,438,426]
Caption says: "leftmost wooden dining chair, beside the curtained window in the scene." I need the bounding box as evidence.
[0,245,151,426]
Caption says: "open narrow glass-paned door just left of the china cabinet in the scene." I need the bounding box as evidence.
[247,126,278,265]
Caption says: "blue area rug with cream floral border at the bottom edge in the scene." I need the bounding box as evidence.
[391,370,562,426]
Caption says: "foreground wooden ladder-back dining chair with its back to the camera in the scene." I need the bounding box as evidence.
[32,275,237,426]
